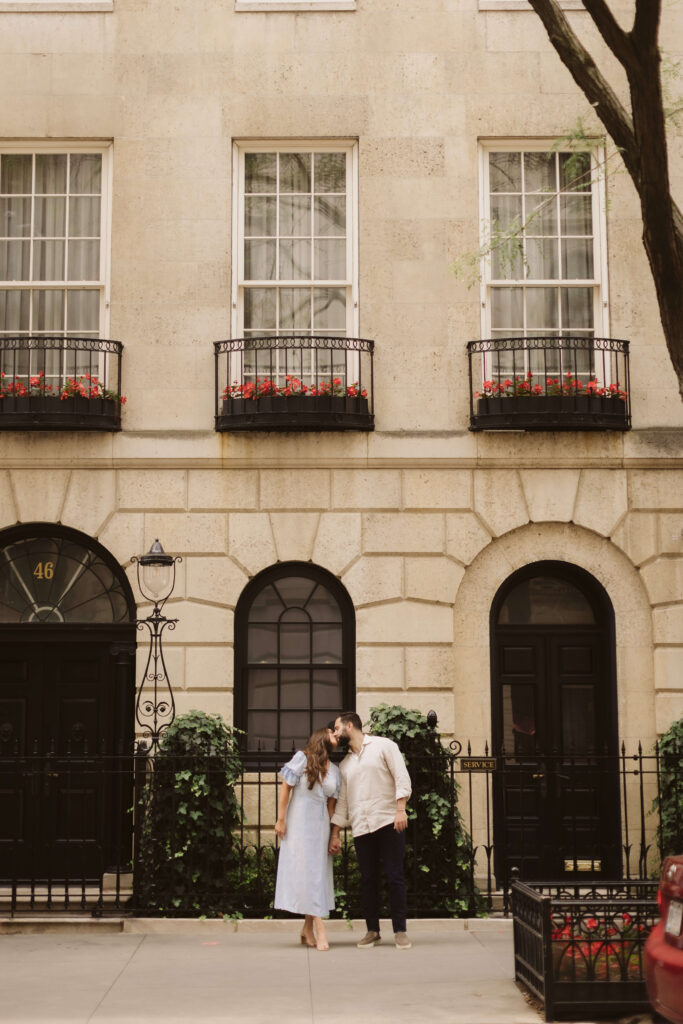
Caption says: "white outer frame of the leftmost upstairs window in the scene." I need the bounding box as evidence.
[0,139,114,339]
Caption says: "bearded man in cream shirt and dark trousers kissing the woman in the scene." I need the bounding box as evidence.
[330,712,412,949]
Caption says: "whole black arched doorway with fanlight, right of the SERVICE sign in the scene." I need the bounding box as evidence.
[490,561,621,880]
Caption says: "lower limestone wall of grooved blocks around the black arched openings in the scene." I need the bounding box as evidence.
[0,467,683,749]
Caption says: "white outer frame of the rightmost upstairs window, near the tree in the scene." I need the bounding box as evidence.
[479,138,609,338]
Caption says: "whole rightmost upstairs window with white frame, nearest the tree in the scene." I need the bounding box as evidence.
[481,143,606,374]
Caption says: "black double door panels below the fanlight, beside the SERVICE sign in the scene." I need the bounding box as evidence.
[493,626,620,881]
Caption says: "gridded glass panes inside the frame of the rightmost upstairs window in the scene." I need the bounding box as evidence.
[484,150,598,381]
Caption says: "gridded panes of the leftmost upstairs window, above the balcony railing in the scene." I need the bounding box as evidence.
[0,153,102,338]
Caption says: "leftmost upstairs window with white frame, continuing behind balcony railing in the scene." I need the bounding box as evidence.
[0,149,109,384]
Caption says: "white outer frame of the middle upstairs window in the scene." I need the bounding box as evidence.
[230,139,358,338]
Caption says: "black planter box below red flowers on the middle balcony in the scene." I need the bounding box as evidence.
[216,394,375,432]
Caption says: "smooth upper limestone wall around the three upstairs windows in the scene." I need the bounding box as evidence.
[0,0,683,432]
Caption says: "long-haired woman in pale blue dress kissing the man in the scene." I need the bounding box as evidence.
[273,728,341,950]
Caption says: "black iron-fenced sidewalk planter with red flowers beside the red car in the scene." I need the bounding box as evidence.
[512,880,658,1021]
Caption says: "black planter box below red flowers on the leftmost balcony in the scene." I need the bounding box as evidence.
[0,395,121,431]
